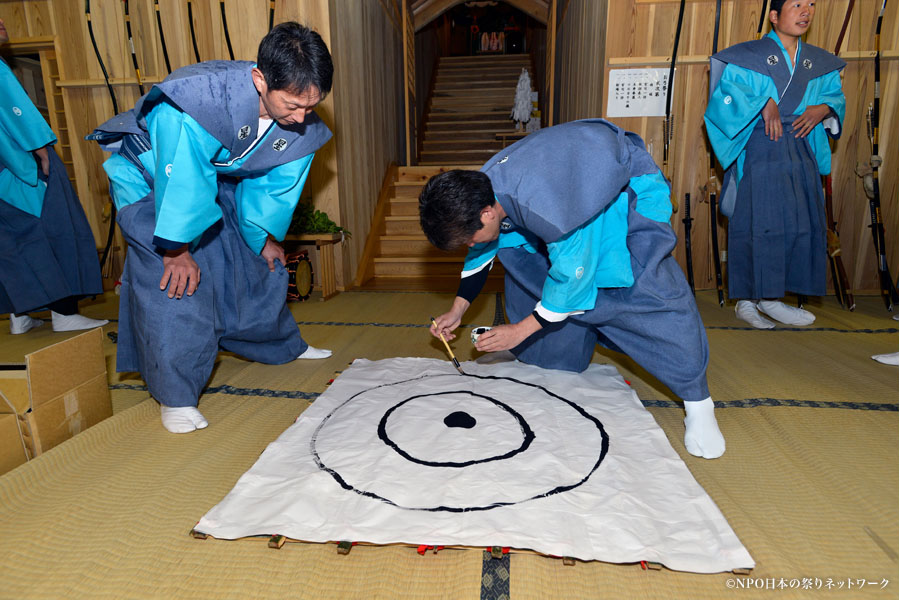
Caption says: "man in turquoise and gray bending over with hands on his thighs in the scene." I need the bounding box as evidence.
[88,22,334,433]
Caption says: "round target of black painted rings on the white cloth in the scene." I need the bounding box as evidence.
[311,371,609,512]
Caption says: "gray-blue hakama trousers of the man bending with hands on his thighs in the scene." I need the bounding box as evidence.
[116,182,307,406]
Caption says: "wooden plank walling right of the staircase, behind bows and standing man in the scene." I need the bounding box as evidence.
[557,0,898,291]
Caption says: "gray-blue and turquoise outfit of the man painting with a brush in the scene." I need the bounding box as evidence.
[463,119,709,400]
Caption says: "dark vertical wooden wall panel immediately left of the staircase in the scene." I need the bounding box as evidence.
[330,0,404,286]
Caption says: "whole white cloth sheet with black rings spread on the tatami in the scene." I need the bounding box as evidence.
[196,358,753,572]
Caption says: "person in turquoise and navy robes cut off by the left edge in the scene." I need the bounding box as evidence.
[0,19,108,335]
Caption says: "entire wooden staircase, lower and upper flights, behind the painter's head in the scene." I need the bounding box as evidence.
[354,54,534,292]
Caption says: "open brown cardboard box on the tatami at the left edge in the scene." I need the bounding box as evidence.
[0,328,112,464]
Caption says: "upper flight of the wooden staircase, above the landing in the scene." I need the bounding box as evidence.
[419,54,534,165]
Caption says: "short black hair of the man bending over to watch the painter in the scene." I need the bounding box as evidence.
[256,21,334,99]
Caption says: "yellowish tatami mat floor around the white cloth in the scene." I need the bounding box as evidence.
[0,291,900,600]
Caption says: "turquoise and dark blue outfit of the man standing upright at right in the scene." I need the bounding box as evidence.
[704,32,845,298]
